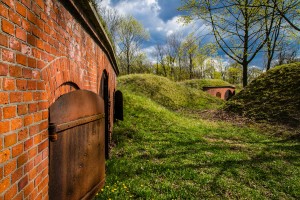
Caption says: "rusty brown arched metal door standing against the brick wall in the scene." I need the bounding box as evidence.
[49,90,105,200]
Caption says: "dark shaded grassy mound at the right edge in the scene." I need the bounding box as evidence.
[226,63,300,127]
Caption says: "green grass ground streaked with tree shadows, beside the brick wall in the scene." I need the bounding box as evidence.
[96,74,300,199]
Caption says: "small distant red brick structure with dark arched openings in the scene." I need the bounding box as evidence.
[203,86,235,100]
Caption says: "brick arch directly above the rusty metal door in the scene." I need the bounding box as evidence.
[41,57,84,106]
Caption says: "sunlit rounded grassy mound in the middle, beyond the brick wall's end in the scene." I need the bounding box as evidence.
[118,74,223,110]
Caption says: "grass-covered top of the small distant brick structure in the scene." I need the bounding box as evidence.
[179,79,232,90]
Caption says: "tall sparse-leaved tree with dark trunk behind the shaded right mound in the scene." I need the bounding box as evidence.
[180,0,275,86]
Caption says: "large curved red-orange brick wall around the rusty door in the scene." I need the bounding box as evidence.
[0,0,116,200]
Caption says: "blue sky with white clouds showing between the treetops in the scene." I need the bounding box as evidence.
[98,0,268,67]
